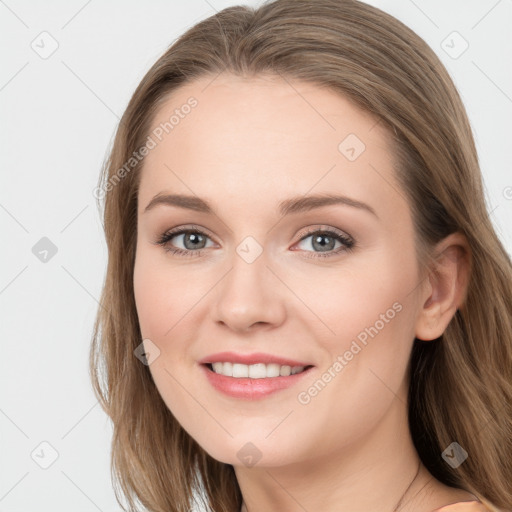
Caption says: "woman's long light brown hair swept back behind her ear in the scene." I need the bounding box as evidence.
[89,0,512,512]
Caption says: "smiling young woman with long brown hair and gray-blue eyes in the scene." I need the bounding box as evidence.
[91,0,512,512]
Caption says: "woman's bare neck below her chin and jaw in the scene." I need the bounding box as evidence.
[235,399,433,512]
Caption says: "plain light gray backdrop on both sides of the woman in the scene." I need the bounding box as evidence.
[0,0,512,512]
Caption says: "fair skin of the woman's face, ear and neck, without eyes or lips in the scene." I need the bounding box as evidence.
[134,73,474,512]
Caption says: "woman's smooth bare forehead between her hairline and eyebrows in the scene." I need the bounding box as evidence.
[139,74,398,216]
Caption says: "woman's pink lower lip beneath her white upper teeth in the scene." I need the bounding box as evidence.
[201,364,313,400]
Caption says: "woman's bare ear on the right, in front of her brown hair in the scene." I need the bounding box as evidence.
[415,233,471,340]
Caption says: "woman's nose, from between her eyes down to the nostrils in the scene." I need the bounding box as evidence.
[210,236,284,329]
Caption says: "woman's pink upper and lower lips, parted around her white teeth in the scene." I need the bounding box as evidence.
[199,352,312,400]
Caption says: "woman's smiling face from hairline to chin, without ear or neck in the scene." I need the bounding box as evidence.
[134,74,425,466]
